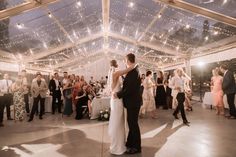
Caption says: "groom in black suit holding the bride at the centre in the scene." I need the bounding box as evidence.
[114,53,142,154]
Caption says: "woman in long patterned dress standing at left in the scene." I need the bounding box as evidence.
[12,74,25,121]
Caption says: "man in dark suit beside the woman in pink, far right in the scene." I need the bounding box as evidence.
[220,64,236,119]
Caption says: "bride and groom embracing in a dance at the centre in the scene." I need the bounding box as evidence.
[108,53,142,155]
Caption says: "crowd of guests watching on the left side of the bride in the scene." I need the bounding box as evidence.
[0,70,107,127]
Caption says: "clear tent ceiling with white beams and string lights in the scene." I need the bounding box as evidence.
[0,0,236,69]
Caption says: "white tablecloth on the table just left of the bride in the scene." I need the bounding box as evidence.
[91,97,110,119]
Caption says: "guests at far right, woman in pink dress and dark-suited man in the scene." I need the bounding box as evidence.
[211,65,236,119]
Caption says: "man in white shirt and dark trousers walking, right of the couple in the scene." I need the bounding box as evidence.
[173,69,189,125]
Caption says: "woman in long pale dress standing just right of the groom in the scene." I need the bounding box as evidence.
[140,71,156,118]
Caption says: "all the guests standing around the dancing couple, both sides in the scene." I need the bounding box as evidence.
[0,62,236,127]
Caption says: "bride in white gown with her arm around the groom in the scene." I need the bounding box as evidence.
[108,60,135,155]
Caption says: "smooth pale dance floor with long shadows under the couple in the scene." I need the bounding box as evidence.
[0,103,236,157]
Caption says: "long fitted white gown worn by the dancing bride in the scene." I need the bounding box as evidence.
[108,76,126,155]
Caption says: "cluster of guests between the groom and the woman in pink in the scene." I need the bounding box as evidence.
[140,69,192,124]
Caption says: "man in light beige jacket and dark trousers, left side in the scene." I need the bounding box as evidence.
[28,72,48,122]
